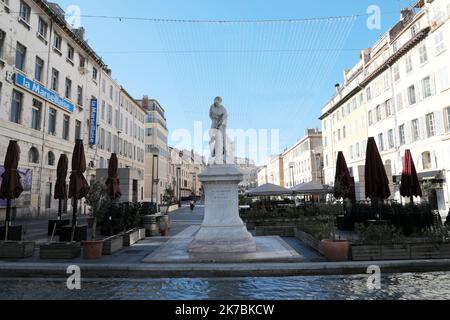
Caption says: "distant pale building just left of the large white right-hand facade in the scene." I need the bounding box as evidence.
[281,129,323,188]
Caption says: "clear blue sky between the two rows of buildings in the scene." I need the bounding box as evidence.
[57,0,408,163]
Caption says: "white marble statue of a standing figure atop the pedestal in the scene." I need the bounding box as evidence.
[209,97,234,165]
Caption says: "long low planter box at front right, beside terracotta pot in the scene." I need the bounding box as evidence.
[350,243,450,261]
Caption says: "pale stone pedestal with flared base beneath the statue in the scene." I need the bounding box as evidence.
[189,165,256,253]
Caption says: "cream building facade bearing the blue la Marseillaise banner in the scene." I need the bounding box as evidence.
[0,0,143,219]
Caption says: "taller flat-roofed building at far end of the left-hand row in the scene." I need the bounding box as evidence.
[138,96,170,204]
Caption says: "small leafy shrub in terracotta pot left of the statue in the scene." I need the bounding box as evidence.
[83,181,110,260]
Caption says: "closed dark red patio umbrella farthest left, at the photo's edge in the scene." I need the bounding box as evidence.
[0,140,23,240]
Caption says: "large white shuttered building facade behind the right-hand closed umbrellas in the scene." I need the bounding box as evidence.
[321,0,450,215]
